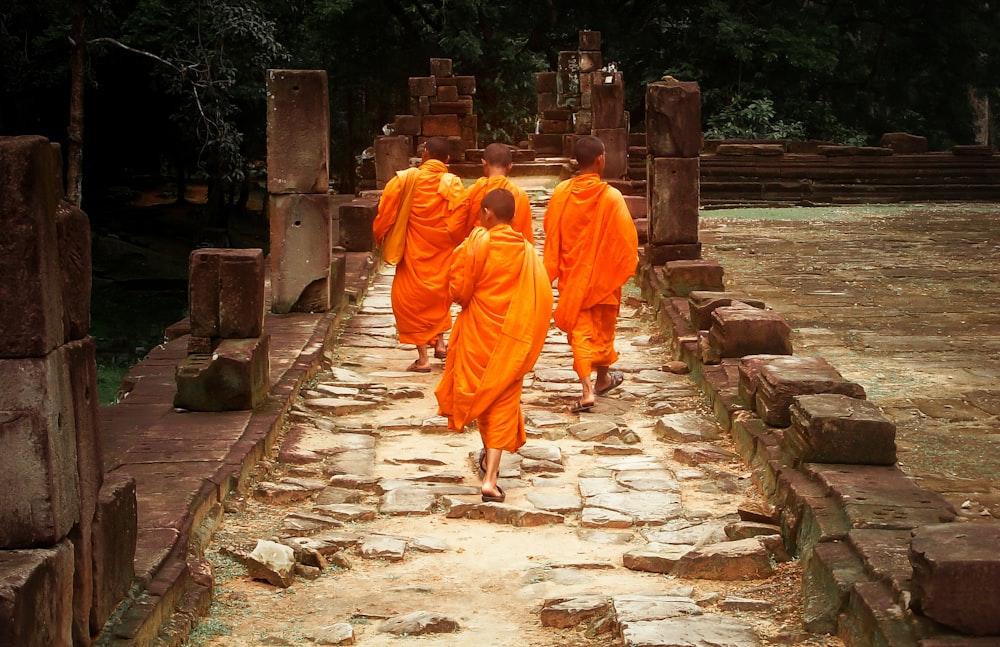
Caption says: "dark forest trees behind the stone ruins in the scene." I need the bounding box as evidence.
[0,0,1000,222]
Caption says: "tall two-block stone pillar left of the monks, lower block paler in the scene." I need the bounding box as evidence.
[267,70,337,314]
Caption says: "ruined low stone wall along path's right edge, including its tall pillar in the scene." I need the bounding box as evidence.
[638,85,1000,647]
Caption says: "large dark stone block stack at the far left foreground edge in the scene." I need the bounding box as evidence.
[0,136,136,647]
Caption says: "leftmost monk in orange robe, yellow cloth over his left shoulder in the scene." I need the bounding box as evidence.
[372,137,464,373]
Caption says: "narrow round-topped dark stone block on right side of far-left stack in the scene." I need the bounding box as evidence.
[56,200,93,341]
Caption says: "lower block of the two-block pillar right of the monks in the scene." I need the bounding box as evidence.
[646,157,701,245]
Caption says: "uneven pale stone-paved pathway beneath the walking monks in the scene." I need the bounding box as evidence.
[192,246,840,647]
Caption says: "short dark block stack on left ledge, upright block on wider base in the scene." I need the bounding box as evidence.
[174,249,270,411]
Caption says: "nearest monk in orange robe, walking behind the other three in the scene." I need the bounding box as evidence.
[434,189,552,502]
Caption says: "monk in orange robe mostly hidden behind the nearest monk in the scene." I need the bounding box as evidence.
[448,142,535,244]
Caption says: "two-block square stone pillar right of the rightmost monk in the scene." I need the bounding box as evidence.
[645,77,701,265]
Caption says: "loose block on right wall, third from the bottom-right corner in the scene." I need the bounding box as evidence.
[754,357,865,430]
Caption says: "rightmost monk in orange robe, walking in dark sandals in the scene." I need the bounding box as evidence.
[543,135,639,412]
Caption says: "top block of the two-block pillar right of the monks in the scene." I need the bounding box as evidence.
[646,79,701,157]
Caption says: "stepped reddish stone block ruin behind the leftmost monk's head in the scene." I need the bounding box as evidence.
[375,58,479,184]
